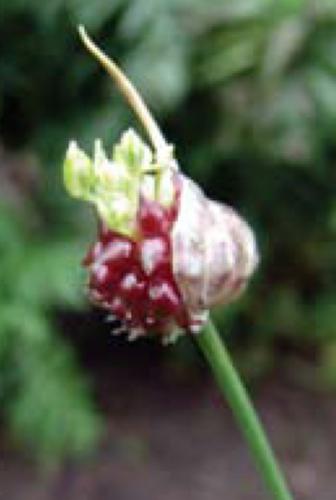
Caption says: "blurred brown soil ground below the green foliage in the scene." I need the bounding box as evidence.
[0,328,336,500]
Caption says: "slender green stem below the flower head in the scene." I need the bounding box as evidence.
[196,322,293,500]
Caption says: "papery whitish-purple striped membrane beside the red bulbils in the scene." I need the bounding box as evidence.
[171,174,258,330]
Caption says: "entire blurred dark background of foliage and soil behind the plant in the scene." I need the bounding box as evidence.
[0,0,336,500]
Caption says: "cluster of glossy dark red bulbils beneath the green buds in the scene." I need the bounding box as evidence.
[83,189,188,335]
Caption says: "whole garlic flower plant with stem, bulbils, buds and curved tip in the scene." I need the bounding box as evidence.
[64,28,292,500]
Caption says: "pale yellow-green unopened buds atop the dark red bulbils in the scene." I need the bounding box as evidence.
[64,129,174,236]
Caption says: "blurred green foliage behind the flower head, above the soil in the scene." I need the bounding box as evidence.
[0,0,336,459]
